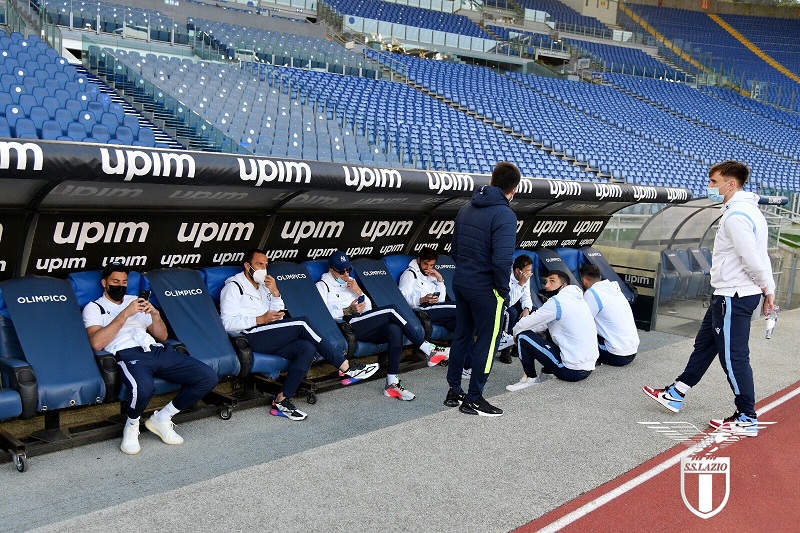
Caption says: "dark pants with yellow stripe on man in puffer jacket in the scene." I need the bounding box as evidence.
[447,285,505,402]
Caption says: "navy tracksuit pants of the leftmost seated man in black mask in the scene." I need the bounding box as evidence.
[115,345,219,418]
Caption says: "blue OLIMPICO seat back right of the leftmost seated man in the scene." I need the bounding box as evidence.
[146,268,240,378]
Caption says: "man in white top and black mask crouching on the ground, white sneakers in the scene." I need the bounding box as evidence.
[506,270,598,391]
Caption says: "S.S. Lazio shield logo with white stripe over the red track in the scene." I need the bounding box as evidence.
[681,456,731,519]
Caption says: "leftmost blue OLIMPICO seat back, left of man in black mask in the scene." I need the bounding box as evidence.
[2,276,106,411]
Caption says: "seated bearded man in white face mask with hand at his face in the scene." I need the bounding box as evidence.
[219,249,378,420]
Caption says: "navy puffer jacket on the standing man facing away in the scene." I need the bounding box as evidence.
[451,185,517,298]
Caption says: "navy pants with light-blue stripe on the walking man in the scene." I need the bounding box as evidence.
[678,294,761,416]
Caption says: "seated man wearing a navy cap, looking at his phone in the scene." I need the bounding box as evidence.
[317,250,446,401]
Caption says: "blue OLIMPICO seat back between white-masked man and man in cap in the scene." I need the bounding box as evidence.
[269,261,347,360]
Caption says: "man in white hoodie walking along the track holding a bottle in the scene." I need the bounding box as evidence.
[643,161,775,437]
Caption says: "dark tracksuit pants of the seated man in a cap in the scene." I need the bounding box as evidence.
[349,305,425,374]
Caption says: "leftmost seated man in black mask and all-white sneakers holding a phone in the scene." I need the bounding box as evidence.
[83,262,218,455]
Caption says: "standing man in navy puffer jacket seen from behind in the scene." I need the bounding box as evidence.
[444,161,521,416]
